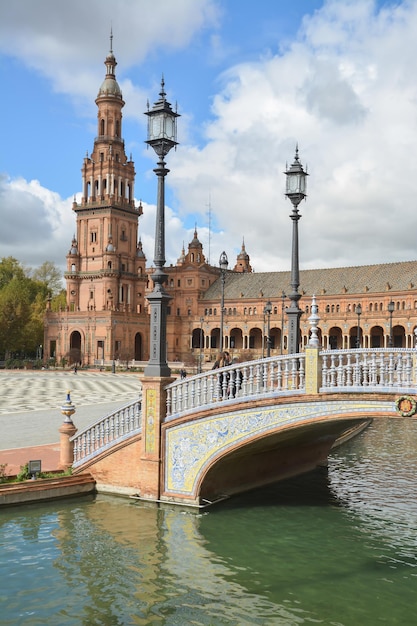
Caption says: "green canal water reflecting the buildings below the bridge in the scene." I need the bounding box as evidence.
[0,418,417,626]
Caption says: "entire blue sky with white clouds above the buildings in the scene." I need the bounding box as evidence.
[0,0,417,272]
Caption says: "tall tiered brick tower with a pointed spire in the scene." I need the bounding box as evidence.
[45,36,149,365]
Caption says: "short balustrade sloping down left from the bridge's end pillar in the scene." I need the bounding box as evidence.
[71,396,142,468]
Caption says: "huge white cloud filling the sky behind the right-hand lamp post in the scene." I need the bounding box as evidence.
[172,1,417,271]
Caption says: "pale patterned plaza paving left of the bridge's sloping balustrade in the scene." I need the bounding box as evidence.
[0,370,140,475]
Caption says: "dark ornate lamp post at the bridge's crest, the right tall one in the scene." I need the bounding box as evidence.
[285,145,308,354]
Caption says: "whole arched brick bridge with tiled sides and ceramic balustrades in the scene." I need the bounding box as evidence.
[70,348,417,505]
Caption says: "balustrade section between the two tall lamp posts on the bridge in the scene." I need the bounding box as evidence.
[166,354,305,419]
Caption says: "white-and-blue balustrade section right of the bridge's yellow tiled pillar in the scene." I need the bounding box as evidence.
[320,348,416,392]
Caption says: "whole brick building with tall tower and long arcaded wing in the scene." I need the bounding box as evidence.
[44,50,417,367]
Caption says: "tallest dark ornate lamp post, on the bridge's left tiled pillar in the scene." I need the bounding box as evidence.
[144,78,179,377]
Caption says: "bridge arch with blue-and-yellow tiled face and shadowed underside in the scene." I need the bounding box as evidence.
[162,394,397,503]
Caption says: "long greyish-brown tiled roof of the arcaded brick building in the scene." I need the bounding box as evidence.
[203,261,417,300]
